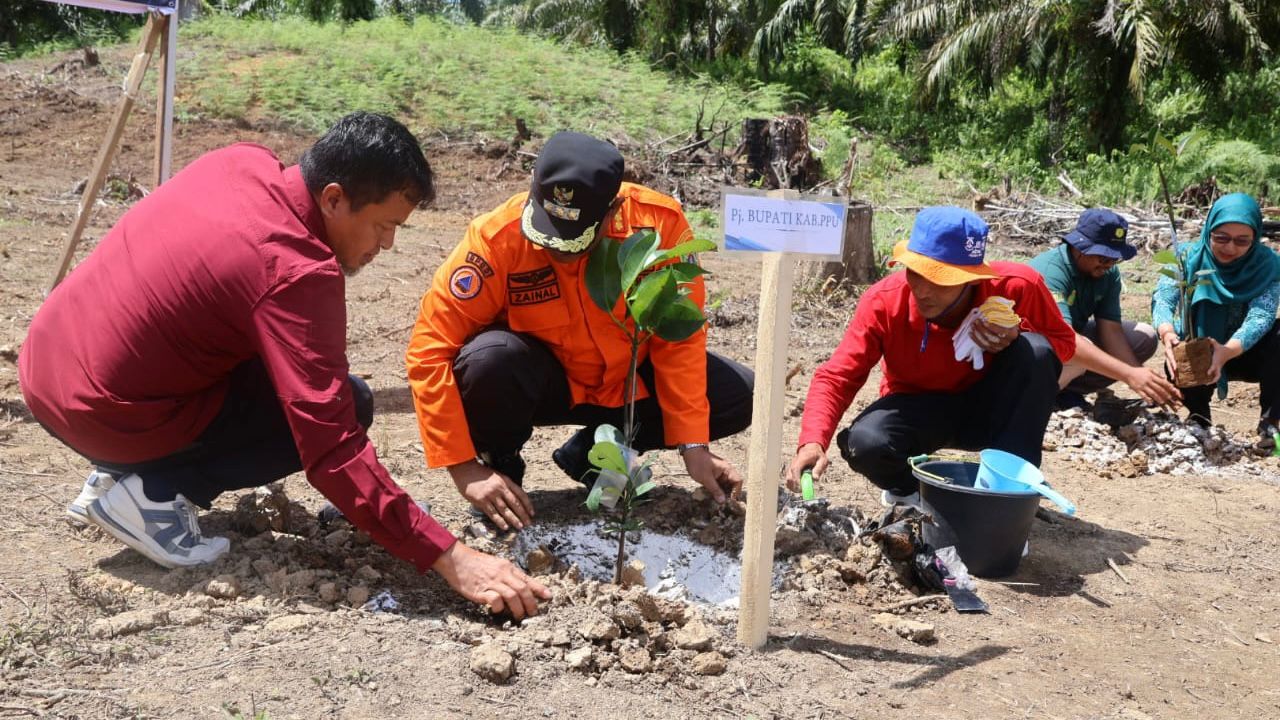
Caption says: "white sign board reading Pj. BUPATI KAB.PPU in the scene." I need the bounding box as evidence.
[722,187,846,260]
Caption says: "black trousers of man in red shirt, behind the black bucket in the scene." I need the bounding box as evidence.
[836,333,1062,495]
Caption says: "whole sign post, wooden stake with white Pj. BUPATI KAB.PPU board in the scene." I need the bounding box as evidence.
[723,188,845,648]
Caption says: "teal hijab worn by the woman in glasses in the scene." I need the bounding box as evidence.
[1185,192,1280,342]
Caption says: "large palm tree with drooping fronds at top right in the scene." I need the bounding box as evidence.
[868,0,1276,150]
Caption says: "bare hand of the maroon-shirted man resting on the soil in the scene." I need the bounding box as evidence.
[431,542,552,620]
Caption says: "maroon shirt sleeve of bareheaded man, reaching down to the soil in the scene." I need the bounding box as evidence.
[252,268,454,571]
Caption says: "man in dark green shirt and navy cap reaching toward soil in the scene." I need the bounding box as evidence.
[1029,208,1180,407]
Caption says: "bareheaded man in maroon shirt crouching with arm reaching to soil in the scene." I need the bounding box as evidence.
[18,113,549,618]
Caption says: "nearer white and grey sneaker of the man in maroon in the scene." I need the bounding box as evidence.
[88,473,232,568]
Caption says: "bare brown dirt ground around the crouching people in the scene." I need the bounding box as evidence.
[0,47,1280,719]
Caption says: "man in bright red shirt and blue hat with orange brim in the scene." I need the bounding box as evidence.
[787,208,1075,503]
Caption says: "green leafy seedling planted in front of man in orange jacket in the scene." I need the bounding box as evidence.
[586,228,716,584]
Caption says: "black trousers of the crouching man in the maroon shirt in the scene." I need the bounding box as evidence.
[83,360,374,509]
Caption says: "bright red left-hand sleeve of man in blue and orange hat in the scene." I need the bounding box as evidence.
[796,288,884,448]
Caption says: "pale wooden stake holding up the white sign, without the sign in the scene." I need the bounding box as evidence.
[737,242,795,648]
